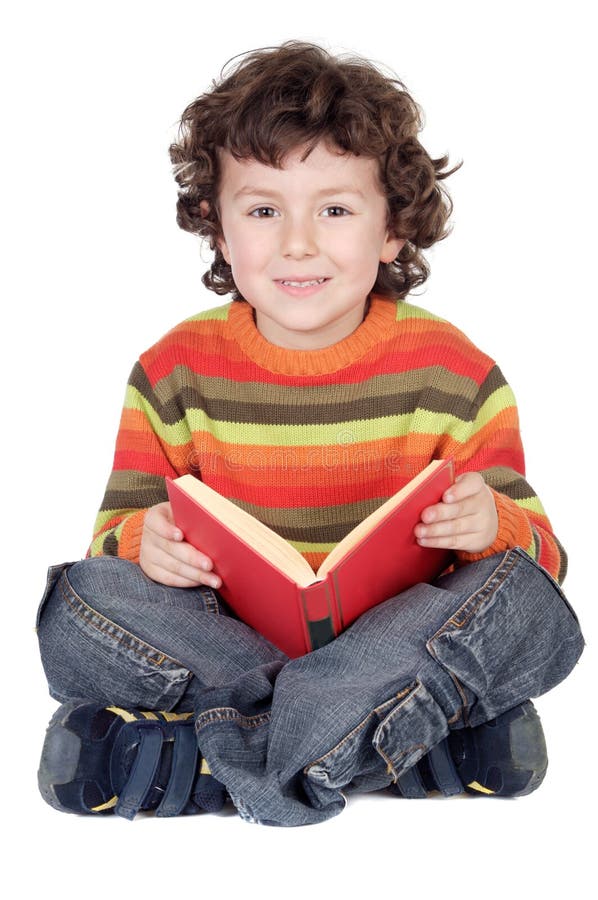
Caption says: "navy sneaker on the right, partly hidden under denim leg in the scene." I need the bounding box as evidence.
[393,700,548,797]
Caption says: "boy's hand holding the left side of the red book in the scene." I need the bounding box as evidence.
[139,503,222,588]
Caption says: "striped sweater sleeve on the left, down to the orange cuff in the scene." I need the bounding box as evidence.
[87,362,189,562]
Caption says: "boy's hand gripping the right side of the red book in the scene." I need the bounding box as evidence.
[415,472,498,553]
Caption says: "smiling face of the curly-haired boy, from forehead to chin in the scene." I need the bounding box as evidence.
[213,143,404,349]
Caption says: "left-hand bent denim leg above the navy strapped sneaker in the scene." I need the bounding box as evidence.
[37,557,287,711]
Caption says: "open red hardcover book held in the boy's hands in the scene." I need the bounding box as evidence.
[167,459,454,657]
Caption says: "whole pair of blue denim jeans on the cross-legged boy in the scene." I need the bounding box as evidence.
[38,549,583,825]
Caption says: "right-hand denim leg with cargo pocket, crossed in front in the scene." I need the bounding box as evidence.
[195,550,583,825]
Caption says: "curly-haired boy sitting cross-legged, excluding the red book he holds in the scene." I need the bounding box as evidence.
[38,42,583,825]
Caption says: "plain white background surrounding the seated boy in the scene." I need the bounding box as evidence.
[0,0,598,898]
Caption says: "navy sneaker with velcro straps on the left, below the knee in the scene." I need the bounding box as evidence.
[38,700,227,819]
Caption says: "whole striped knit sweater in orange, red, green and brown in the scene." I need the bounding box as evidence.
[89,296,566,579]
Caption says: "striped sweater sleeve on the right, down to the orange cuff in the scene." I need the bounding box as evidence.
[452,366,567,581]
